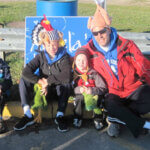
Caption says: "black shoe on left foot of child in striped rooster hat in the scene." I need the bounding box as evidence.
[14,115,35,130]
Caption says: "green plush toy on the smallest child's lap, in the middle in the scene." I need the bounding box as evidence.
[83,92,102,115]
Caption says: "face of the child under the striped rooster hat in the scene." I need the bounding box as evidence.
[44,40,59,58]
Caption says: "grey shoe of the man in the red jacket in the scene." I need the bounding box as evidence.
[107,122,120,137]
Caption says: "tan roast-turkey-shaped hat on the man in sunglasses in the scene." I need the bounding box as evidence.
[87,4,111,31]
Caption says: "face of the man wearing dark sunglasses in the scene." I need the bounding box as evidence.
[92,28,111,47]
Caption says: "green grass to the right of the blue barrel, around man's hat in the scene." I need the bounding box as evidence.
[78,4,150,32]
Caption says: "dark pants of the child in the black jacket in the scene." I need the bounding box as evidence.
[19,78,71,112]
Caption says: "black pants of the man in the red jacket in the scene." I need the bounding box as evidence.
[105,84,150,137]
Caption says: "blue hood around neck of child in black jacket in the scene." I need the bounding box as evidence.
[44,47,66,65]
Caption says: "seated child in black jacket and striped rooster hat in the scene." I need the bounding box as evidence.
[14,16,72,132]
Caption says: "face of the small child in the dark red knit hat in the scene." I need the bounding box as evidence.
[75,54,88,72]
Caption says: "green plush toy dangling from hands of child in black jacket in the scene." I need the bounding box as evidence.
[31,84,47,123]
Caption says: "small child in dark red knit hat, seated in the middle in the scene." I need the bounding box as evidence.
[73,48,107,130]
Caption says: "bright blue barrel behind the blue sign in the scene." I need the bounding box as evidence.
[36,0,77,16]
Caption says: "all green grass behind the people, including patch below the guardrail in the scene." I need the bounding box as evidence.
[0,0,150,84]
